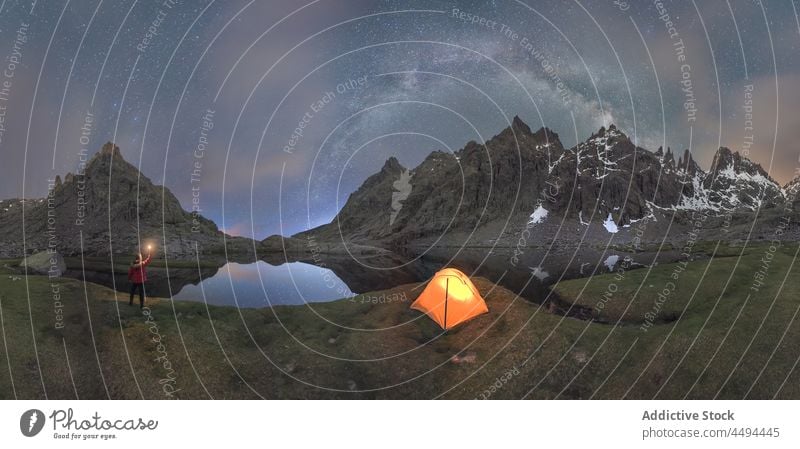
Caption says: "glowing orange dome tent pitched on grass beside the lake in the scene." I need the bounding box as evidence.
[411,268,489,329]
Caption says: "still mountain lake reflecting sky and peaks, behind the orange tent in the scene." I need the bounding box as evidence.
[65,248,664,308]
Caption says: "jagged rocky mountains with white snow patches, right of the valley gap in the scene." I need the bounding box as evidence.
[295,117,800,245]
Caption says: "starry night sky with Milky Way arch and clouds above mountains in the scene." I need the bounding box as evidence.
[0,0,800,239]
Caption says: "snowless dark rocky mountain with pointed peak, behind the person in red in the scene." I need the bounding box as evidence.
[0,142,253,258]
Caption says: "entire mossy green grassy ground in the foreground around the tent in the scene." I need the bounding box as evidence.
[0,244,800,399]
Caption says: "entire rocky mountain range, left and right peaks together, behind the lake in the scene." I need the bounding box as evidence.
[0,122,800,259]
